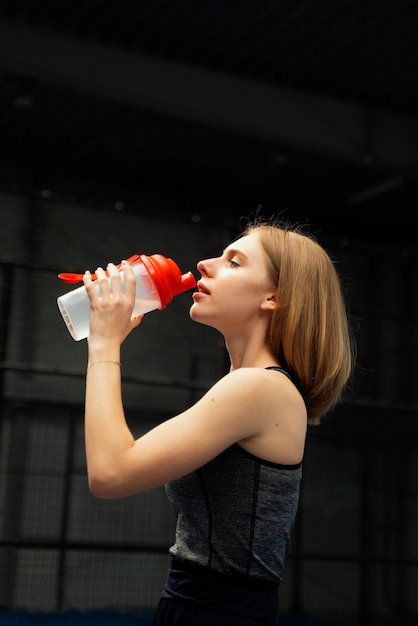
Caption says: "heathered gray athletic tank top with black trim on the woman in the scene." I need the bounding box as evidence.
[166,368,302,582]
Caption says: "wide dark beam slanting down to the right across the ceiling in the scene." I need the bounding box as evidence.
[0,20,418,175]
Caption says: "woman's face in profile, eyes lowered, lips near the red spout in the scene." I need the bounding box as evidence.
[190,232,276,332]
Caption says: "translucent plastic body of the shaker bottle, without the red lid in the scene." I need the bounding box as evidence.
[57,262,161,341]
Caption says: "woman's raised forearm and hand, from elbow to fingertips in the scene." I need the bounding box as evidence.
[83,263,142,495]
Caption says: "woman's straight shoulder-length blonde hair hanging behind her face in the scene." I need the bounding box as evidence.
[241,219,354,424]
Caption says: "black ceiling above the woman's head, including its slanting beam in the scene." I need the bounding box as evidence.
[0,0,418,241]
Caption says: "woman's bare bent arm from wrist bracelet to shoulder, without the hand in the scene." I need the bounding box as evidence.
[85,364,290,498]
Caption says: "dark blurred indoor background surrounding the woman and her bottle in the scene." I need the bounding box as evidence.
[0,0,418,626]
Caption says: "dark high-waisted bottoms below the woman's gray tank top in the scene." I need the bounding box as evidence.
[153,563,279,626]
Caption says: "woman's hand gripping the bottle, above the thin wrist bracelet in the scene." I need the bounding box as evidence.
[83,261,143,348]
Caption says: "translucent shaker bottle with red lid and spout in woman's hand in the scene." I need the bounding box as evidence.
[57,254,196,341]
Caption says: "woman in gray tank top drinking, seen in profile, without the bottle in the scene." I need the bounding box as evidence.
[84,220,353,626]
